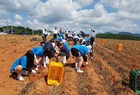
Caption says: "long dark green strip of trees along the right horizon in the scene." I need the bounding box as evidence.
[96,34,140,40]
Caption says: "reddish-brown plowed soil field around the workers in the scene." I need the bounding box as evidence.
[0,35,140,95]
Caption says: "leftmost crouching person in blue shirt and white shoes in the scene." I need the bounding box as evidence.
[10,50,36,81]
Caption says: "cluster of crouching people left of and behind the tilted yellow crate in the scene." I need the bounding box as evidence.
[10,42,57,80]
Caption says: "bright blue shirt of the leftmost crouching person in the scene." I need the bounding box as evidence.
[10,55,27,73]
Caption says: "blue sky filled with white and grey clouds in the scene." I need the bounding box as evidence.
[0,0,140,33]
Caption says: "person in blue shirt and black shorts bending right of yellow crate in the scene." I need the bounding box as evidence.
[71,45,88,73]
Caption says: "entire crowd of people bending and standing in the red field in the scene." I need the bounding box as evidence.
[10,27,96,80]
